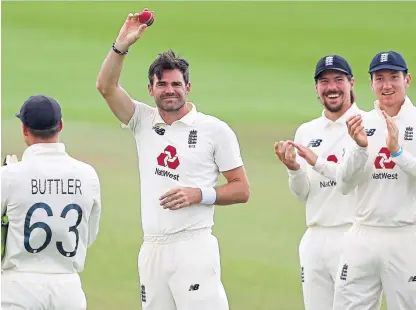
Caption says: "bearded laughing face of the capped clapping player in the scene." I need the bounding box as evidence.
[315,70,354,113]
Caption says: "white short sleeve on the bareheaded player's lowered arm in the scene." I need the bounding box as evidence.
[214,122,243,172]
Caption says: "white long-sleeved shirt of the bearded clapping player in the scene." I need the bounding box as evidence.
[287,103,361,227]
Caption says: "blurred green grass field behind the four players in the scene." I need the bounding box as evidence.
[1,1,416,310]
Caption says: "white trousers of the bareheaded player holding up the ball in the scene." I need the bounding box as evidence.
[138,229,229,310]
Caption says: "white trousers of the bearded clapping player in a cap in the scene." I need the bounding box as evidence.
[299,225,360,310]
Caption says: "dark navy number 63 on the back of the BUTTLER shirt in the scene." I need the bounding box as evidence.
[24,202,82,257]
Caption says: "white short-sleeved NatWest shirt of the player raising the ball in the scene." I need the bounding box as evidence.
[128,101,243,236]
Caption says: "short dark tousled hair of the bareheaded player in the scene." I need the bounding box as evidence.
[148,50,189,85]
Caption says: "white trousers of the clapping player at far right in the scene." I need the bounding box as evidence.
[334,224,416,310]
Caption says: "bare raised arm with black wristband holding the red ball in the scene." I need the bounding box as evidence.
[96,13,151,124]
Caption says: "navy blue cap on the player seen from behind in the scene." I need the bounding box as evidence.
[16,95,62,130]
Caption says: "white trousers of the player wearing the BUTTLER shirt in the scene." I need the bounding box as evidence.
[1,270,87,310]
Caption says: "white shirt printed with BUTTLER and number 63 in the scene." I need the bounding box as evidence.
[1,143,101,274]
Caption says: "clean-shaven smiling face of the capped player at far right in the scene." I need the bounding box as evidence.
[371,70,411,109]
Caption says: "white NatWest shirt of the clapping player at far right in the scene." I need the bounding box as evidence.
[338,97,416,227]
